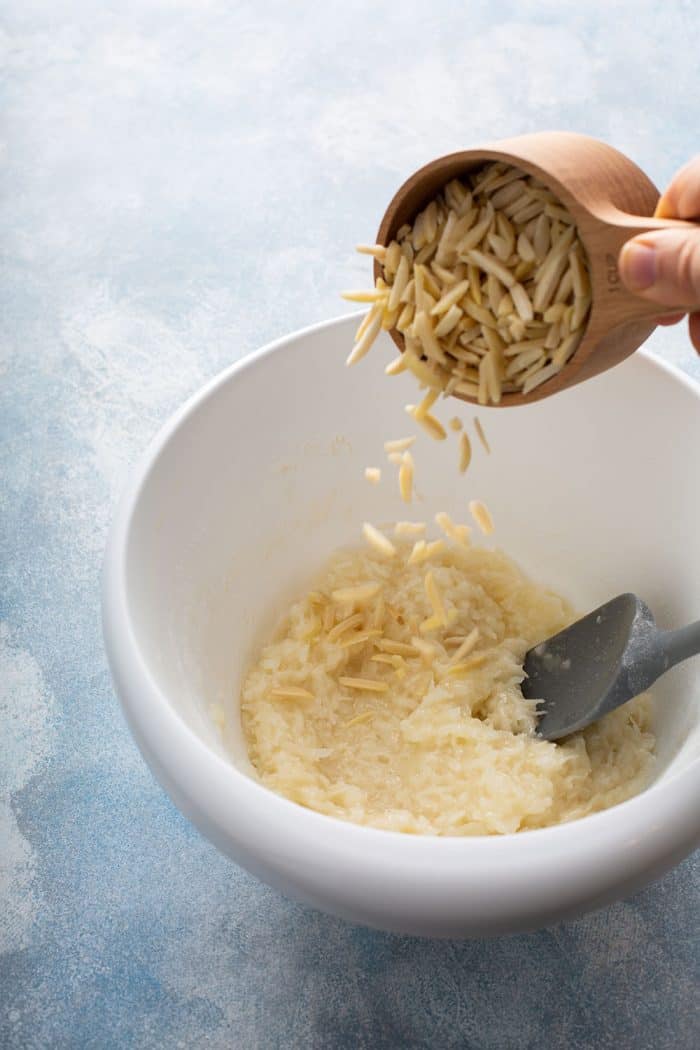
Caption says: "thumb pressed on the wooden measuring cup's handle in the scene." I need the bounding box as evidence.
[619,227,700,311]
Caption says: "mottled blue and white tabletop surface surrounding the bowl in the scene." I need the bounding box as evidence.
[0,0,700,1050]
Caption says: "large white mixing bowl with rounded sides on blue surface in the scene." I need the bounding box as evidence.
[103,318,700,937]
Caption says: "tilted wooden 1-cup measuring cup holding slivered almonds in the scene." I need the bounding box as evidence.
[375,131,695,405]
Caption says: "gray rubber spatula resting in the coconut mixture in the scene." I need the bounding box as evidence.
[523,594,700,740]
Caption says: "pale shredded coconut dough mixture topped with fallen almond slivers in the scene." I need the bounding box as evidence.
[241,533,654,836]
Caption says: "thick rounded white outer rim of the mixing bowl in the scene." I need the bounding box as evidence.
[102,312,700,887]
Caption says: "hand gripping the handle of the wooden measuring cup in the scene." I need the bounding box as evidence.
[619,156,700,354]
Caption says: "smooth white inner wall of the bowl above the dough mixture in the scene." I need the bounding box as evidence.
[126,318,700,797]
